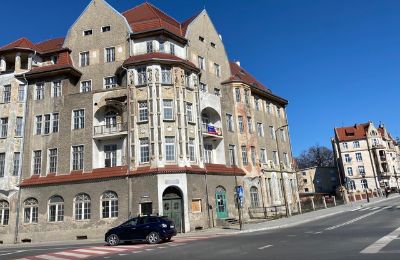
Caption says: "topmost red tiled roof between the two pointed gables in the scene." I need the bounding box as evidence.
[122,2,184,37]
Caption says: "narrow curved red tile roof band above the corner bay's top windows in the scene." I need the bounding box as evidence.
[124,52,198,70]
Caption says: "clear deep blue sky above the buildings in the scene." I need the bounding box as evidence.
[0,0,400,156]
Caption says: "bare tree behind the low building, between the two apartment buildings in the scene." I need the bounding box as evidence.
[296,144,334,169]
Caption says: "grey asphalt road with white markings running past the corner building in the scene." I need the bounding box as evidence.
[0,197,400,260]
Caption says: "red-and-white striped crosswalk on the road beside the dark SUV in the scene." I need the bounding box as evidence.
[18,235,220,260]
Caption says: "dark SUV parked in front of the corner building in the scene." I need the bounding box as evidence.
[105,216,176,246]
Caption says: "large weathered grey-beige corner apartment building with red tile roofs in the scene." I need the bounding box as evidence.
[0,0,298,243]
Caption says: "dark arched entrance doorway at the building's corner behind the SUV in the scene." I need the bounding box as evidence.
[163,186,184,233]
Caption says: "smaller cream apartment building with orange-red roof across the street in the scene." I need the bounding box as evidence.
[332,122,400,193]
